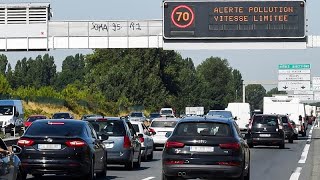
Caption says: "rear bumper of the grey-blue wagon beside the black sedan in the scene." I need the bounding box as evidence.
[107,150,132,164]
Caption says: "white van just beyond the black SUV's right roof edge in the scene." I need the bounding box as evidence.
[226,103,251,131]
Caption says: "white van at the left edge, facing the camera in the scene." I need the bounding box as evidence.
[0,100,24,133]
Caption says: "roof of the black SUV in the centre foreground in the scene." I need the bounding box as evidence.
[179,116,234,124]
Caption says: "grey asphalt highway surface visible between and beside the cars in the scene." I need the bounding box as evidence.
[23,128,320,180]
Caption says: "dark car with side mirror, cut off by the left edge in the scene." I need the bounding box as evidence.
[0,138,21,180]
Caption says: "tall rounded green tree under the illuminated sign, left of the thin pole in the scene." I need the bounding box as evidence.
[197,57,235,109]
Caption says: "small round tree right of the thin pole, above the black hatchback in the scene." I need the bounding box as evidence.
[246,84,266,110]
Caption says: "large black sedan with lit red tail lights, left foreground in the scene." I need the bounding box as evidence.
[17,120,108,180]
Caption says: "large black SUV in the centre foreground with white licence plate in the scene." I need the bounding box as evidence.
[162,116,250,180]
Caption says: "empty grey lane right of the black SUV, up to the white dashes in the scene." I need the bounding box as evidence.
[251,133,308,180]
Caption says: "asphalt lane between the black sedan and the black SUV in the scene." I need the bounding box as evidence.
[27,149,162,180]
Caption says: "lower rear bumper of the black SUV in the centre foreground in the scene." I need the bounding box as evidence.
[163,164,243,178]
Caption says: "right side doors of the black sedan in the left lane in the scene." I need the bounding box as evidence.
[87,123,105,170]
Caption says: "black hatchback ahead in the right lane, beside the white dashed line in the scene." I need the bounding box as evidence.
[246,114,285,149]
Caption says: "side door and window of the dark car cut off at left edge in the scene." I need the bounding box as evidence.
[0,139,17,180]
